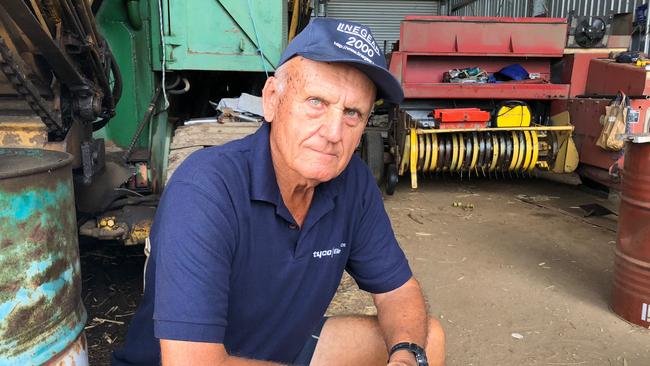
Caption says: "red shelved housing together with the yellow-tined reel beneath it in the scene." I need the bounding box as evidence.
[389,16,577,188]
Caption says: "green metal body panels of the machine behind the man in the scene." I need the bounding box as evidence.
[96,0,288,191]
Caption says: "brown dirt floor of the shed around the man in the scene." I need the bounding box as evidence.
[81,179,650,366]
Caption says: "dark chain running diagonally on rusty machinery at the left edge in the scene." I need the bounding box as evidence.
[0,35,64,133]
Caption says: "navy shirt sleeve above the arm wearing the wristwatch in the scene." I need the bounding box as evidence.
[346,163,413,294]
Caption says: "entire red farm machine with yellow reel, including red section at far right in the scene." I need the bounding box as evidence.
[372,15,648,194]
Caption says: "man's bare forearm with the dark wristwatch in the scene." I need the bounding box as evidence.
[373,277,428,365]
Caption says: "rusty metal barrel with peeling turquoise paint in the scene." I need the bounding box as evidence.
[0,149,88,366]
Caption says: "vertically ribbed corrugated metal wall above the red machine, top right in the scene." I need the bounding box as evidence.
[449,0,646,18]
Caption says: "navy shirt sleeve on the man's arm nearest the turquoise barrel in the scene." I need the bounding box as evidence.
[152,176,237,343]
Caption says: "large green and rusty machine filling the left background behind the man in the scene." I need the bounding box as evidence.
[0,0,298,244]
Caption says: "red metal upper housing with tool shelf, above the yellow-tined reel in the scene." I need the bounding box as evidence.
[390,16,569,99]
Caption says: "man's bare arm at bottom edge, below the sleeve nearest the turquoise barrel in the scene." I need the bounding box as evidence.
[160,339,280,366]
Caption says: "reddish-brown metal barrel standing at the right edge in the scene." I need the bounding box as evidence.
[612,142,650,328]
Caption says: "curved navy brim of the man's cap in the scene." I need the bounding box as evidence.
[281,52,404,104]
